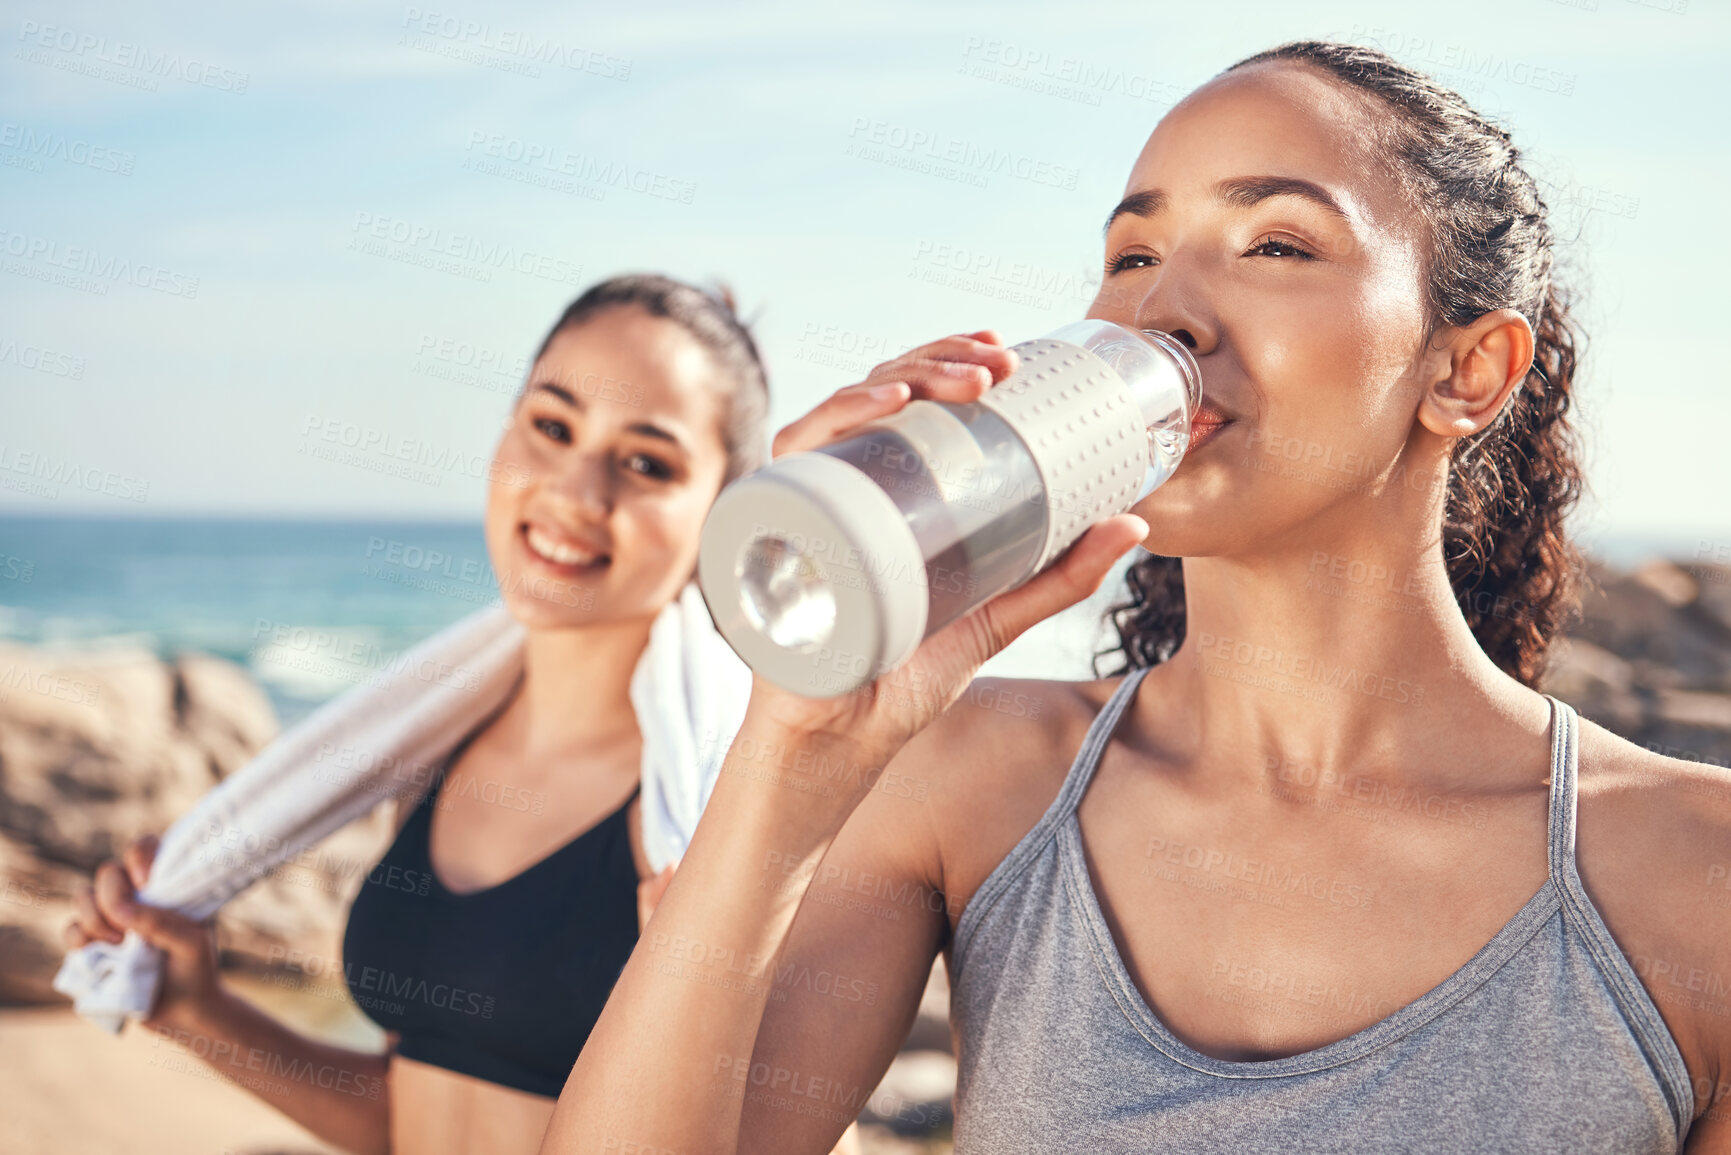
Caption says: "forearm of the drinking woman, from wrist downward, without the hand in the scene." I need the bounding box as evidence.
[542,710,920,1152]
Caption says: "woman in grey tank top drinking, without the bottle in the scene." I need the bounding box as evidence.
[544,43,1731,1155]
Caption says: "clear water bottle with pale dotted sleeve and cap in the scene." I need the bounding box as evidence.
[698,320,1201,698]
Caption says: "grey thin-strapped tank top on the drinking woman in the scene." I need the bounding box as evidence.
[950,668,1695,1155]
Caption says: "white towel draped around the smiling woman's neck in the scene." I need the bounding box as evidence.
[54,584,751,1032]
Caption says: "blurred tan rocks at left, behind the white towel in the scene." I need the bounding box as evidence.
[0,646,389,1003]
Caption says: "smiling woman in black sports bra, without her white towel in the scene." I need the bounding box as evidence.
[68,275,830,1155]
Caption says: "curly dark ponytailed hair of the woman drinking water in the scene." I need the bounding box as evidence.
[1096,40,1584,686]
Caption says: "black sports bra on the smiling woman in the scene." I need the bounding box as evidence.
[343,746,637,1096]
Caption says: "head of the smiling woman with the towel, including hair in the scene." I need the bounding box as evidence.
[486,279,767,640]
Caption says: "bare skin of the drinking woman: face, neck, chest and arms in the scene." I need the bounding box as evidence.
[542,64,1731,1152]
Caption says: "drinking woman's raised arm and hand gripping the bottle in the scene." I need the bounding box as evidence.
[542,334,1148,1155]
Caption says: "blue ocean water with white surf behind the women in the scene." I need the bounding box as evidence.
[0,516,1695,726]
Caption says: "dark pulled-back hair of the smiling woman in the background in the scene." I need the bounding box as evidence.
[535,274,769,485]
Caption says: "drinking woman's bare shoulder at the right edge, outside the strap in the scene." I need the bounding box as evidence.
[1575,719,1731,1107]
